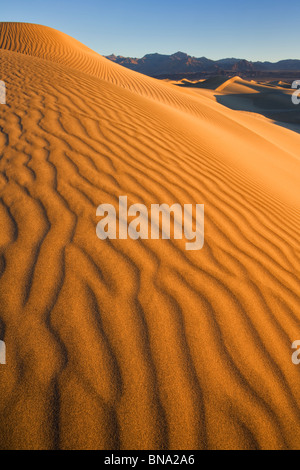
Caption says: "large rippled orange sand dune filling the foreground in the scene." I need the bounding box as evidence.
[0,23,300,449]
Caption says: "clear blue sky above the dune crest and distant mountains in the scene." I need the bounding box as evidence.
[0,0,300,61]
